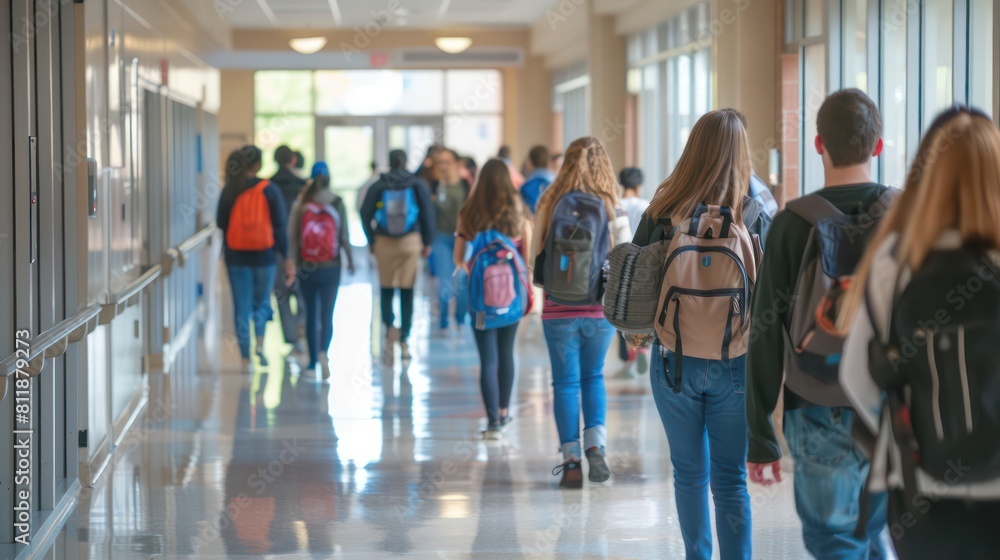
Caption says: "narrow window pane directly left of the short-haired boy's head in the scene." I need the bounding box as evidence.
[802,43,827,194]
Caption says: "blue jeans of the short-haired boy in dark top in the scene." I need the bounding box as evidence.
[784,406,887,560]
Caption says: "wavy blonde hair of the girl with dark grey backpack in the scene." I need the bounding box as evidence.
[537,136,621,239]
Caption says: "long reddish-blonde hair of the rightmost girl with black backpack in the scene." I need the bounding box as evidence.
[838,109,1000,332]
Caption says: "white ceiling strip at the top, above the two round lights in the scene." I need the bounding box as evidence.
[205,0,559,29]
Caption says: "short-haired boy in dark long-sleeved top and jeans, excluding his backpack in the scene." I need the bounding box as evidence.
[746,89,887,559]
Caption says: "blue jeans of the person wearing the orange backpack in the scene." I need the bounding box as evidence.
[226,264,277,359]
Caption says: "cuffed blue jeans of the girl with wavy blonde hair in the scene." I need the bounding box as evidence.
[542,318,615,460]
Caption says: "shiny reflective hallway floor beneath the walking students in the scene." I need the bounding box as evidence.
[39,256,820,560]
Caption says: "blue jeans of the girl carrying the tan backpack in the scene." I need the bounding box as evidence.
[650,343,751,560]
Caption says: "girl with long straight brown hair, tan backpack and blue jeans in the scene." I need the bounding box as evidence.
[633,109,759,560]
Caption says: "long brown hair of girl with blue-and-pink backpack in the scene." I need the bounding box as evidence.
[459,159,524,238]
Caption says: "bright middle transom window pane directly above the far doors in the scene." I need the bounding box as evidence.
[316,70,444,115]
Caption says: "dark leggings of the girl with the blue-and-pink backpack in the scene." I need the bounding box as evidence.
[472,323,517,424]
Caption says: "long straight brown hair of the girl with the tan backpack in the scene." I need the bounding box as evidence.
[646,109,753,223]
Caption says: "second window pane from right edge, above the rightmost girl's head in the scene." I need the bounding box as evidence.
[920,0,954,127]
